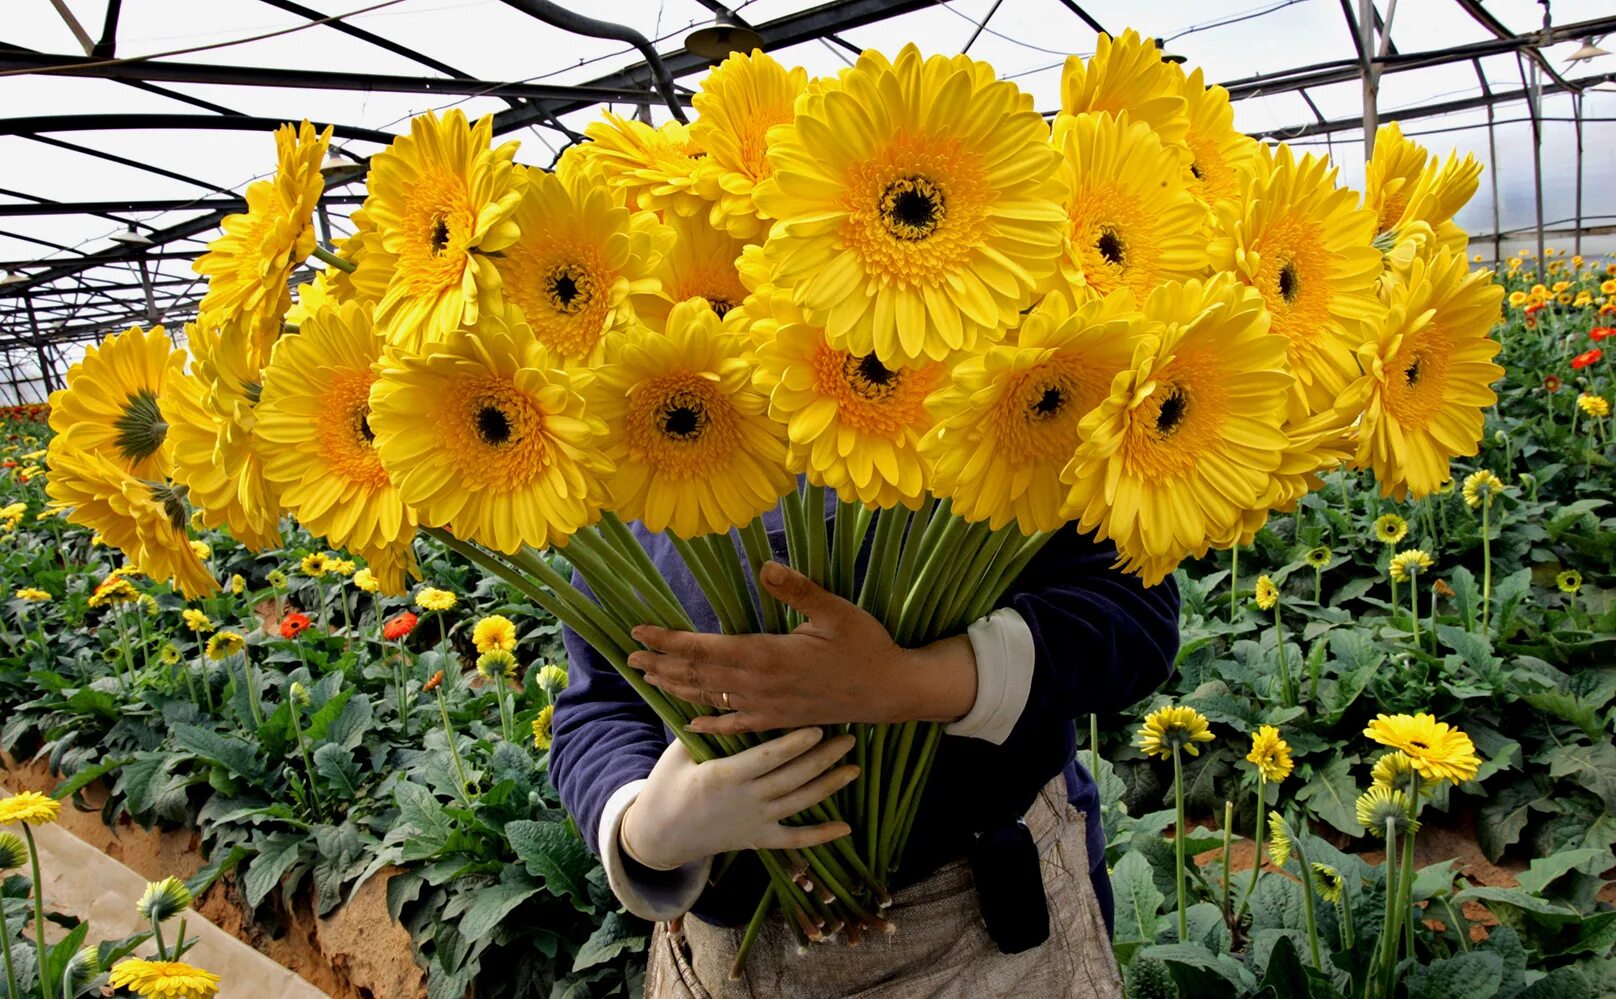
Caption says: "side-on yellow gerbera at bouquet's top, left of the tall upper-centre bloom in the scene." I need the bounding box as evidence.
[561,112,711,217]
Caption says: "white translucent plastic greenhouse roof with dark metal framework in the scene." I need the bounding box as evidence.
[0,0,1616,399]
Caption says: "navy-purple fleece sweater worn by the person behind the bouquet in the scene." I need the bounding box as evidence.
[549,512,1178,926]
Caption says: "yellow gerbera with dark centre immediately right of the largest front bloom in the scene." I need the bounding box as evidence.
[1049,113,1207,301]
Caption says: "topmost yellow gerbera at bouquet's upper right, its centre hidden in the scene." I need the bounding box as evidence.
[1060,27,1189,153]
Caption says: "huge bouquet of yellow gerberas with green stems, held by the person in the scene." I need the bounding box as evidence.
[37,31,1501,963]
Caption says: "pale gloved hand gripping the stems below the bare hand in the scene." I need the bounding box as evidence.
[617,727,858,871]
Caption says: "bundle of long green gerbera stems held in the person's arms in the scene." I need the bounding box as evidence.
[428,485,1049,973]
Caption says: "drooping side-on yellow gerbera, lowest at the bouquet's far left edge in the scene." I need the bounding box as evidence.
[45,432,218,600]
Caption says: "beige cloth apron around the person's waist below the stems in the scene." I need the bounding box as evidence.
[645,778,1122,999]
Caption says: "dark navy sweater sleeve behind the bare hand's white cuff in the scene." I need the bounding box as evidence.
[1000,525,1178,739]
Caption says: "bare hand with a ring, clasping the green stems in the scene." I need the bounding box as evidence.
[629,563,976,734]
